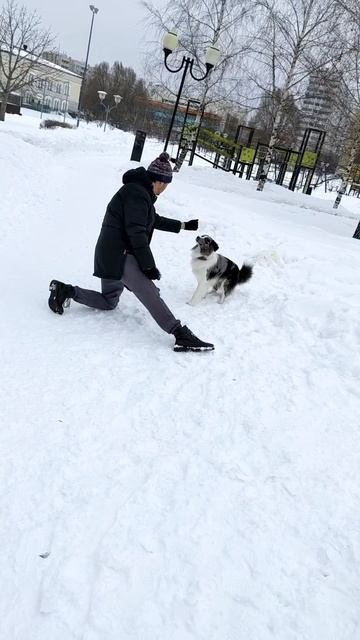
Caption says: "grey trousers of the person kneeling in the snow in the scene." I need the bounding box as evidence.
[74,254,181,333]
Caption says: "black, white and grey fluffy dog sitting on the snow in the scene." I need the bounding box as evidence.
[189,236,253,305]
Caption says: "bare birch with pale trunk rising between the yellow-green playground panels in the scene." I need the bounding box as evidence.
[258,0,343,191]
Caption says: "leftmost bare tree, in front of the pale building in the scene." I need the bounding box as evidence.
[0,0,53,121]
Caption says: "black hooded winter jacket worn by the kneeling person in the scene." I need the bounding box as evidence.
[94,167,181,280]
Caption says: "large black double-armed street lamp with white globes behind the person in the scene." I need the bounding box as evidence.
[163,31,220,151]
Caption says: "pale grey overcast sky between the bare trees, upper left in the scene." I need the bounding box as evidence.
[22,0,161,74]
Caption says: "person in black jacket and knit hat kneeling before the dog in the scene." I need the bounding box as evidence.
[49,153,214,351]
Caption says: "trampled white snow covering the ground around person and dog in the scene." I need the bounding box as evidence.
[0,114,360,640]
